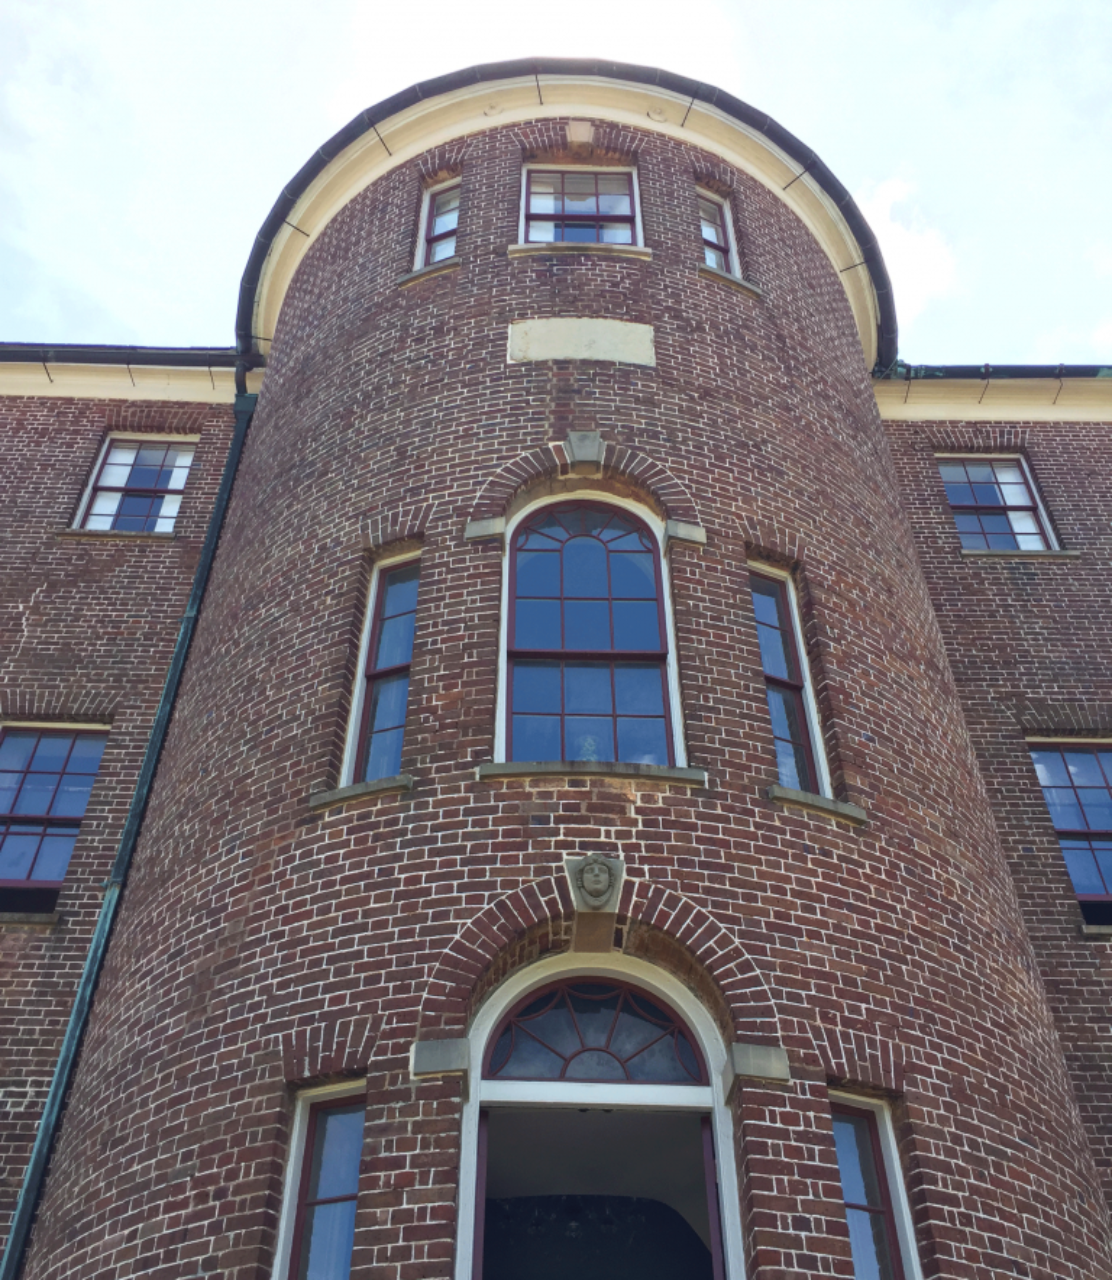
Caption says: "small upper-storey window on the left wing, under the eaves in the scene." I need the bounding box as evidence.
[75,435,196,534]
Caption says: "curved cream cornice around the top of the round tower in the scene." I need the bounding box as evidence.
[238,63,896,369]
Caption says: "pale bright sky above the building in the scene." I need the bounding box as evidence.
[0,0,1112,365]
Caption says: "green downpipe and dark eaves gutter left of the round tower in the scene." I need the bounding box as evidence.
[0,371,258,1280]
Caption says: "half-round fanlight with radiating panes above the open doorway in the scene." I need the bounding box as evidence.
[484,980,706,1084]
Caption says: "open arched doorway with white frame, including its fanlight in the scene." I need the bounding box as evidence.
[456,957,743,1280]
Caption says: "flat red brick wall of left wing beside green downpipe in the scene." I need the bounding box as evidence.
[0,398,232,1238]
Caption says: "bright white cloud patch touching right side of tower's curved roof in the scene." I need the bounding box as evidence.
[856,178,957,333]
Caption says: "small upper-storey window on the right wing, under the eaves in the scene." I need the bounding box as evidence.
[937,454,1058,552]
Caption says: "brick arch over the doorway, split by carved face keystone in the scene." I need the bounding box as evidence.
[417,877,782,1044]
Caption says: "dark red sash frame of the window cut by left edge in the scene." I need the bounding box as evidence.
[0,727,107,911]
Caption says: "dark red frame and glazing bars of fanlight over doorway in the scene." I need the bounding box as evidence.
[482,974,709,1088]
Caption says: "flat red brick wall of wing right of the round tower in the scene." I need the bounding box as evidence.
[887,422,1112,1197]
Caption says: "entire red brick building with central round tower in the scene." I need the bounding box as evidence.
[0,61,1112,1280]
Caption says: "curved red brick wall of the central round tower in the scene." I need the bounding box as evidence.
[17,122,1109,1280]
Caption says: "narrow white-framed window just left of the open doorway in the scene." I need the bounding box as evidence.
[274,1082,366,1280]
